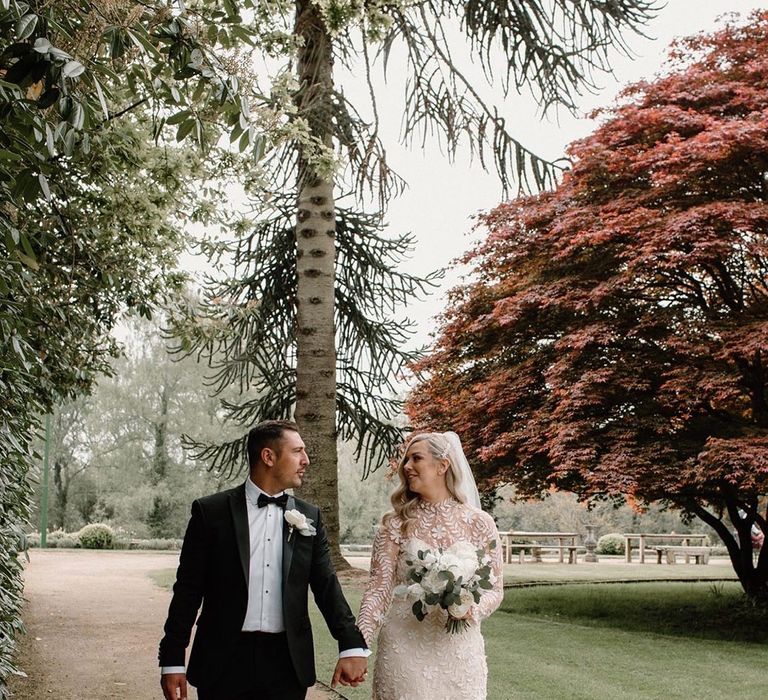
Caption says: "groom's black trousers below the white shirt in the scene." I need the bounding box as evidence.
[197,632,307,700]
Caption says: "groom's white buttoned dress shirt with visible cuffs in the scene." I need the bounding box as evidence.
[160,477,371,674]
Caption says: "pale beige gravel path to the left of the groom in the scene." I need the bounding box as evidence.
[10,549,342,700]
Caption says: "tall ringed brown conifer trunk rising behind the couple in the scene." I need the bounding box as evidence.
[295,0,348,568]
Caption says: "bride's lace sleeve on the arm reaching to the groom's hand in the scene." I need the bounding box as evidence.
[357,518,400,647]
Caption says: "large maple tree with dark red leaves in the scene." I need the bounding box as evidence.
[408,12,768,598]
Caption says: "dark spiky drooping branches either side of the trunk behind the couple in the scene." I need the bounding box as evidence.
[172,197,441,475]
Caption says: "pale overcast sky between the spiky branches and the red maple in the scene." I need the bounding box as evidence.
[368,0,768,342]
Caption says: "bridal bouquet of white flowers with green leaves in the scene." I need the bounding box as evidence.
[395,539,496,634]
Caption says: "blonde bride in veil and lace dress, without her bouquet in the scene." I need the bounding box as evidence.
[357,433,503,700]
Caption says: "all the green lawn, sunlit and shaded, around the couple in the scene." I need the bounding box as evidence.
[155,565,768,700]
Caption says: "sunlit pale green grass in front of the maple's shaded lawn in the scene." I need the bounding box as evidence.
[483,612,768,700]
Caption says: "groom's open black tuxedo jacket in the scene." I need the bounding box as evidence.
[159,484,365,687]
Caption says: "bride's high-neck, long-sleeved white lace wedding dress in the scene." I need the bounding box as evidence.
[357,499,503,700]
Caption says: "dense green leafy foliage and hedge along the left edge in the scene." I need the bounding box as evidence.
[0,0,257,684]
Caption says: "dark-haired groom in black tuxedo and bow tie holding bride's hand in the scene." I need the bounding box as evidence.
[159,421,369,700]
